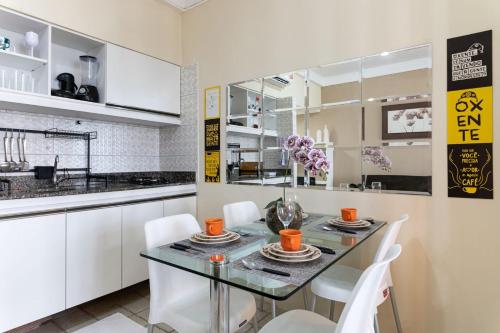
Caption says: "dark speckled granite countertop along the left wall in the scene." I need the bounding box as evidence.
[0,172,196,200]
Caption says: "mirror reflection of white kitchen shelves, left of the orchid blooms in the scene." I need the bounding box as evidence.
[227,71,306,186]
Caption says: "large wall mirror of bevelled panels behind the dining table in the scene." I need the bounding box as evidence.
[226,45,432,195]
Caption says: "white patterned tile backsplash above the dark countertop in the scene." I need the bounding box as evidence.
[0,66,198,173]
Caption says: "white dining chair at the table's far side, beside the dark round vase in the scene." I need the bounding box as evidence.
[223,201,307,318]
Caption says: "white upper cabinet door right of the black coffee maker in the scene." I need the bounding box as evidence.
[106,44,181,115]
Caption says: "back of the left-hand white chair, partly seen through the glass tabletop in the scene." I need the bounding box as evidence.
[144,214,209,324]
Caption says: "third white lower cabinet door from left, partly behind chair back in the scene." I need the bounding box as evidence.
[122,201,163,288]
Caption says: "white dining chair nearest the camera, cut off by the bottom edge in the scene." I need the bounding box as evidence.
[259,244,401,333]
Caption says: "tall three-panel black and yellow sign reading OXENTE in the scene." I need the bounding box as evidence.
[447,31,493,199]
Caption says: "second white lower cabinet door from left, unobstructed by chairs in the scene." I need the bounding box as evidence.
[66,207,122,308]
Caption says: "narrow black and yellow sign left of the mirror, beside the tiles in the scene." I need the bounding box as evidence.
[205,87,220,183]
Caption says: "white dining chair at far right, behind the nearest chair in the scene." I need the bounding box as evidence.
[311,214,408,333]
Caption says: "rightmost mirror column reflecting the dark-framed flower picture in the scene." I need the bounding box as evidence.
[362,46,432,193]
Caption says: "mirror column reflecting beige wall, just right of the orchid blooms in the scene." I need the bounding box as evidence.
[298,59,361,189]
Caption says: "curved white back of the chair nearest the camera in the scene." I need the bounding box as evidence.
[335,244,401,333]
